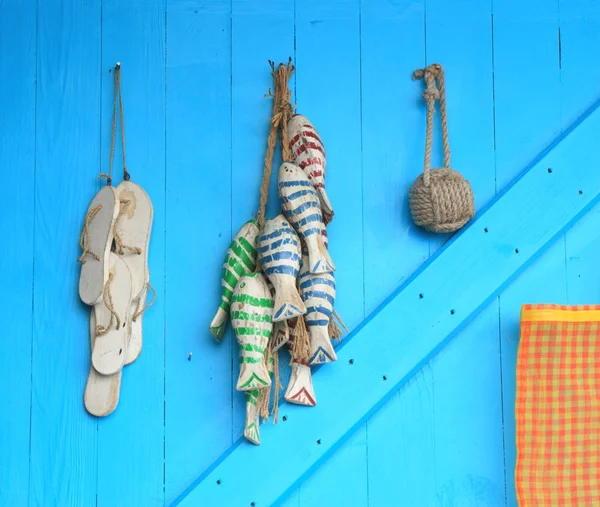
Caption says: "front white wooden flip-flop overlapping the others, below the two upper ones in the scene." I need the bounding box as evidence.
[92,252,132,375]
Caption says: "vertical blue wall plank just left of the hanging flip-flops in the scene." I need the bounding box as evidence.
[29,1,101,507]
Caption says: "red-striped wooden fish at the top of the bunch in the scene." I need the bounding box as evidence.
[288,114,334,223]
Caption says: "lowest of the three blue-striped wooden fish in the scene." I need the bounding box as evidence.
[298,256,337,365]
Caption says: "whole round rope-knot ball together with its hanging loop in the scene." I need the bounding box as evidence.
[409,63,475,232]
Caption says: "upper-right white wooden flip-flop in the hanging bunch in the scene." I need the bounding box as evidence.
[114,181,154,301]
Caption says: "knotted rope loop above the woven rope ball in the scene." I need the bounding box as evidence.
[413,63,451,187]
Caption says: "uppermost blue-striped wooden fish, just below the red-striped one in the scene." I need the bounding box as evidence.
[279,162,335,274]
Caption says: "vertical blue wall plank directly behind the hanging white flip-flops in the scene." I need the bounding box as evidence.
[97,0,166,507]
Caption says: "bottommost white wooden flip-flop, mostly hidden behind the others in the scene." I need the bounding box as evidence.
[83,308,122,417]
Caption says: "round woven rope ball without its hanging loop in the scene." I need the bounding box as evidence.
[408,167,475,232]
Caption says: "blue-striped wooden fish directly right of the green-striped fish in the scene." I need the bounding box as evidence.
[258,215,306,322]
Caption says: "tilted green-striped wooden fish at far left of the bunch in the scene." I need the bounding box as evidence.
[210,220,258,341]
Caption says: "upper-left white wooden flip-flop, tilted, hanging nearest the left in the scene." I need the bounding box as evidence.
[78,185,119,306]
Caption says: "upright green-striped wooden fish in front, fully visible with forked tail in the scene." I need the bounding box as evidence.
[229,273,273,391]
